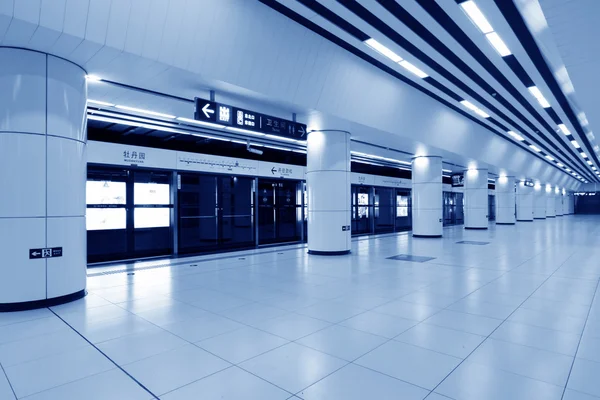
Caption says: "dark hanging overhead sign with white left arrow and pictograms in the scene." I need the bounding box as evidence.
[194,97,308,140]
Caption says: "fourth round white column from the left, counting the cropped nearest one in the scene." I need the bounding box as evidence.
[465,168,489,229]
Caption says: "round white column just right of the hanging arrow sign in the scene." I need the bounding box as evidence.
[306,130,351,255]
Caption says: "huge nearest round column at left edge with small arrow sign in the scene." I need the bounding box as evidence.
[0,47,87,311]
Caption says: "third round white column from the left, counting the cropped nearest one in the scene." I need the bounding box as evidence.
[412,156,443,238]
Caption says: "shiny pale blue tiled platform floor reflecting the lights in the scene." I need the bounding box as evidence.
[0,216,600,400]
